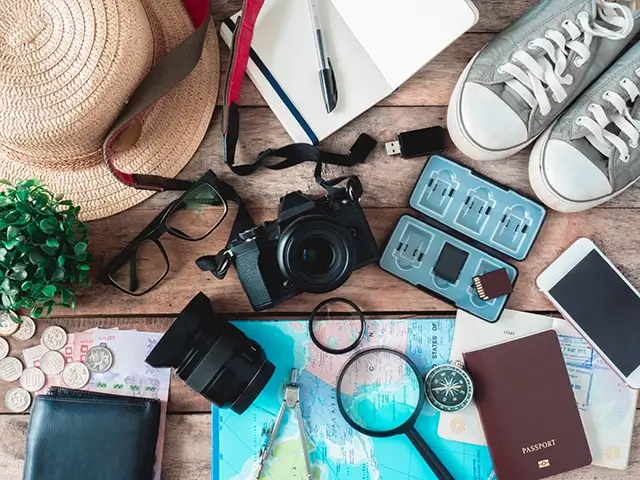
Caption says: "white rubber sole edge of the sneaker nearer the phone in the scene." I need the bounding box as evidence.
[529,122,638,213]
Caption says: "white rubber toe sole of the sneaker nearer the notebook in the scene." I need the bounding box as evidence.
[447,50,536,161]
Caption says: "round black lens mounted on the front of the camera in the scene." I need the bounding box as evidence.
[278,215,355,293]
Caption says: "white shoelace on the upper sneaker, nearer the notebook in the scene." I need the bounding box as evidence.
[498,0,634,115]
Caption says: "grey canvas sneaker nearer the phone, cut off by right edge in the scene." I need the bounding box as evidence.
[529,43,640,212]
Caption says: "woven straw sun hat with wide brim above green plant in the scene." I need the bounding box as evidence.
[0,0,220,220]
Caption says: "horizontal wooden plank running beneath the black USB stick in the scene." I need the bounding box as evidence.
[141,107,640,209]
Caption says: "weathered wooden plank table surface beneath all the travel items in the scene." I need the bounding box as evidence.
[0,0,640,480]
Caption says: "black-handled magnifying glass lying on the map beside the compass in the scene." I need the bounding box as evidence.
[337,348,454,480]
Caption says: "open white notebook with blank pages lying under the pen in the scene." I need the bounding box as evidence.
[221,0,478,143]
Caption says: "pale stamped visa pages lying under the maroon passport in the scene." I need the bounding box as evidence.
[438,310,638,470]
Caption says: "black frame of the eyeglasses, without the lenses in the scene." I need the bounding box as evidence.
[98,170,230,297]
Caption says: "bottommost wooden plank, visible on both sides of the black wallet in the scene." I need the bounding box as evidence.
[0,415,640,480]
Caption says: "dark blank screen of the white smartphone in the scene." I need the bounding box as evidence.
[549,250,640,377]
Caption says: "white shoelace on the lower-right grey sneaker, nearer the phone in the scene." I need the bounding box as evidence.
[576,69,640,163]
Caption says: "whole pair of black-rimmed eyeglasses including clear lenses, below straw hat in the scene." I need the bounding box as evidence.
[99,170,229,296]
